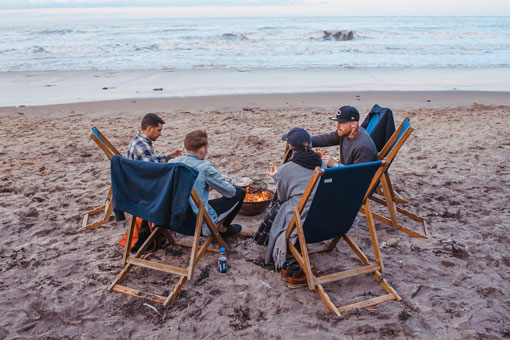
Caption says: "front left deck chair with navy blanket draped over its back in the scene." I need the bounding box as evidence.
[107,157,227,307]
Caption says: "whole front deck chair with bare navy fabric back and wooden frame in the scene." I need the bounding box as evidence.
[285,160,401,317]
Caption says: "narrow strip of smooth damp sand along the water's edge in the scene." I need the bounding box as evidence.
[0,91,510,117]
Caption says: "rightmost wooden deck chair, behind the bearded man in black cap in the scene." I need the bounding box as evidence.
[361,118,429,238]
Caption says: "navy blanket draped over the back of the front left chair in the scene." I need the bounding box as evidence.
[110,156,198,234]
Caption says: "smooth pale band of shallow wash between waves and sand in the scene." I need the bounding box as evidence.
[0,68,510,107]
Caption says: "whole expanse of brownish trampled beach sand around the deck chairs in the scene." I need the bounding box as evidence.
[0,92,510,339]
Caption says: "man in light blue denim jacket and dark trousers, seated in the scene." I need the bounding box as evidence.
[169,130,246,237]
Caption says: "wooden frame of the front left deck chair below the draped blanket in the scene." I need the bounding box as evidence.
[107,189,227,307]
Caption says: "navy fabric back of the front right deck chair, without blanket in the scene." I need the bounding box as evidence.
[303,161,383,243]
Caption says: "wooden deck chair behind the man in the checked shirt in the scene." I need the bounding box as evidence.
[81,127,120,230]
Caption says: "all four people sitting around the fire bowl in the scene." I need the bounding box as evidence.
[126,106,378,284]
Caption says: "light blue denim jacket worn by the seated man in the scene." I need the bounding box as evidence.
[168,154,236,236]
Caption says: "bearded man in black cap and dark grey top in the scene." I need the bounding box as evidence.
[312,106,378,168]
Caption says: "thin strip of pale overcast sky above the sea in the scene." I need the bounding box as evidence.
[0,0,510,16]
